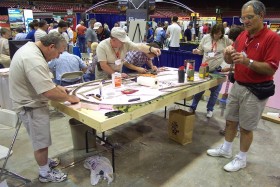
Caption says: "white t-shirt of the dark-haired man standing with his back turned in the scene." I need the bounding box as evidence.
[166,23,181,47]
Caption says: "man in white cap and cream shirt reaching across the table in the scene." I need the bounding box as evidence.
[95,27,161,79]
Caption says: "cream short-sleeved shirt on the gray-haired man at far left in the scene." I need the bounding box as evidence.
[9,42,55,111]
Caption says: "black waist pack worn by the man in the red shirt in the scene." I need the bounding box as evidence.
[238,80,275,100]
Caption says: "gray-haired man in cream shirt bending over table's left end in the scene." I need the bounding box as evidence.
[9,32,79,182]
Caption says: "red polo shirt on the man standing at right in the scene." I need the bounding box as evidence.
[234,26,280,83]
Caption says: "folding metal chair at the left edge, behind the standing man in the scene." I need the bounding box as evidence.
[0,109,31,183]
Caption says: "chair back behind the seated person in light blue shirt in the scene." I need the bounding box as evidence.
[60,71,84,86]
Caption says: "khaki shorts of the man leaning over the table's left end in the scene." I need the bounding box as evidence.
[19,107,52,151]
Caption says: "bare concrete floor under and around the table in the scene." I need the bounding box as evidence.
[0,101,280,187]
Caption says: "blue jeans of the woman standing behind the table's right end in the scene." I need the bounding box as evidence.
[191,84,223,111]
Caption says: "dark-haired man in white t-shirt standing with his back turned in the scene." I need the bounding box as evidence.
[166,16,181,51]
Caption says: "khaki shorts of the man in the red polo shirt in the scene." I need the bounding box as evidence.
[225,81,268,131]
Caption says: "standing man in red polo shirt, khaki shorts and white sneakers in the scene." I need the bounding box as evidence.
[207,0,280,171]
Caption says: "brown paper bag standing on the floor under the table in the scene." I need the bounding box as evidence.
[168,109,195,145]
